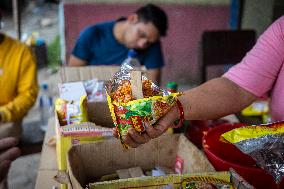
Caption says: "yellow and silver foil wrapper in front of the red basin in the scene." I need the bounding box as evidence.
[222,121,284,184]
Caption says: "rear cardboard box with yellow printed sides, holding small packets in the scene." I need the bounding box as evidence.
[55,66,120,189]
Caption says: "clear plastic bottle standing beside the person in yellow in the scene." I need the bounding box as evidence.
[39,83,53,131]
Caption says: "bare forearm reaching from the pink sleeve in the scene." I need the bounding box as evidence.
[179,77,257,120]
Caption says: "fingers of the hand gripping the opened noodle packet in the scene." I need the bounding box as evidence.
[113,102,179,148]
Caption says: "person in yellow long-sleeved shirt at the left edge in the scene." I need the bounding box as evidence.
[0,12,39,189]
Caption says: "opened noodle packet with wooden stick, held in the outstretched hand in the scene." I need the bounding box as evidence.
[105,65,180,148]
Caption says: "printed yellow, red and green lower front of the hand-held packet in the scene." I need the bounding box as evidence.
[107,93,180,148]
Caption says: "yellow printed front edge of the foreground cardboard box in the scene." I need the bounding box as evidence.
[89,172,233,189]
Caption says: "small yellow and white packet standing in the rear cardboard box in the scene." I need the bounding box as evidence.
[55,96,88,126]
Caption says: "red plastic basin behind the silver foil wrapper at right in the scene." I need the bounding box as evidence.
[202,124,284,189]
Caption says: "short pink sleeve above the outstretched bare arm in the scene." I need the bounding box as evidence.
[224,16,284,97]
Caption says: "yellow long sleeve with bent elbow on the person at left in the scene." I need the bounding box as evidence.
[0,48,39,122]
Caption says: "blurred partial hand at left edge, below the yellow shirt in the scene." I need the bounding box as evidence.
[0,137,21,182]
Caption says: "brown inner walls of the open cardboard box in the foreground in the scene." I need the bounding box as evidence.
[64,134,214,189]
